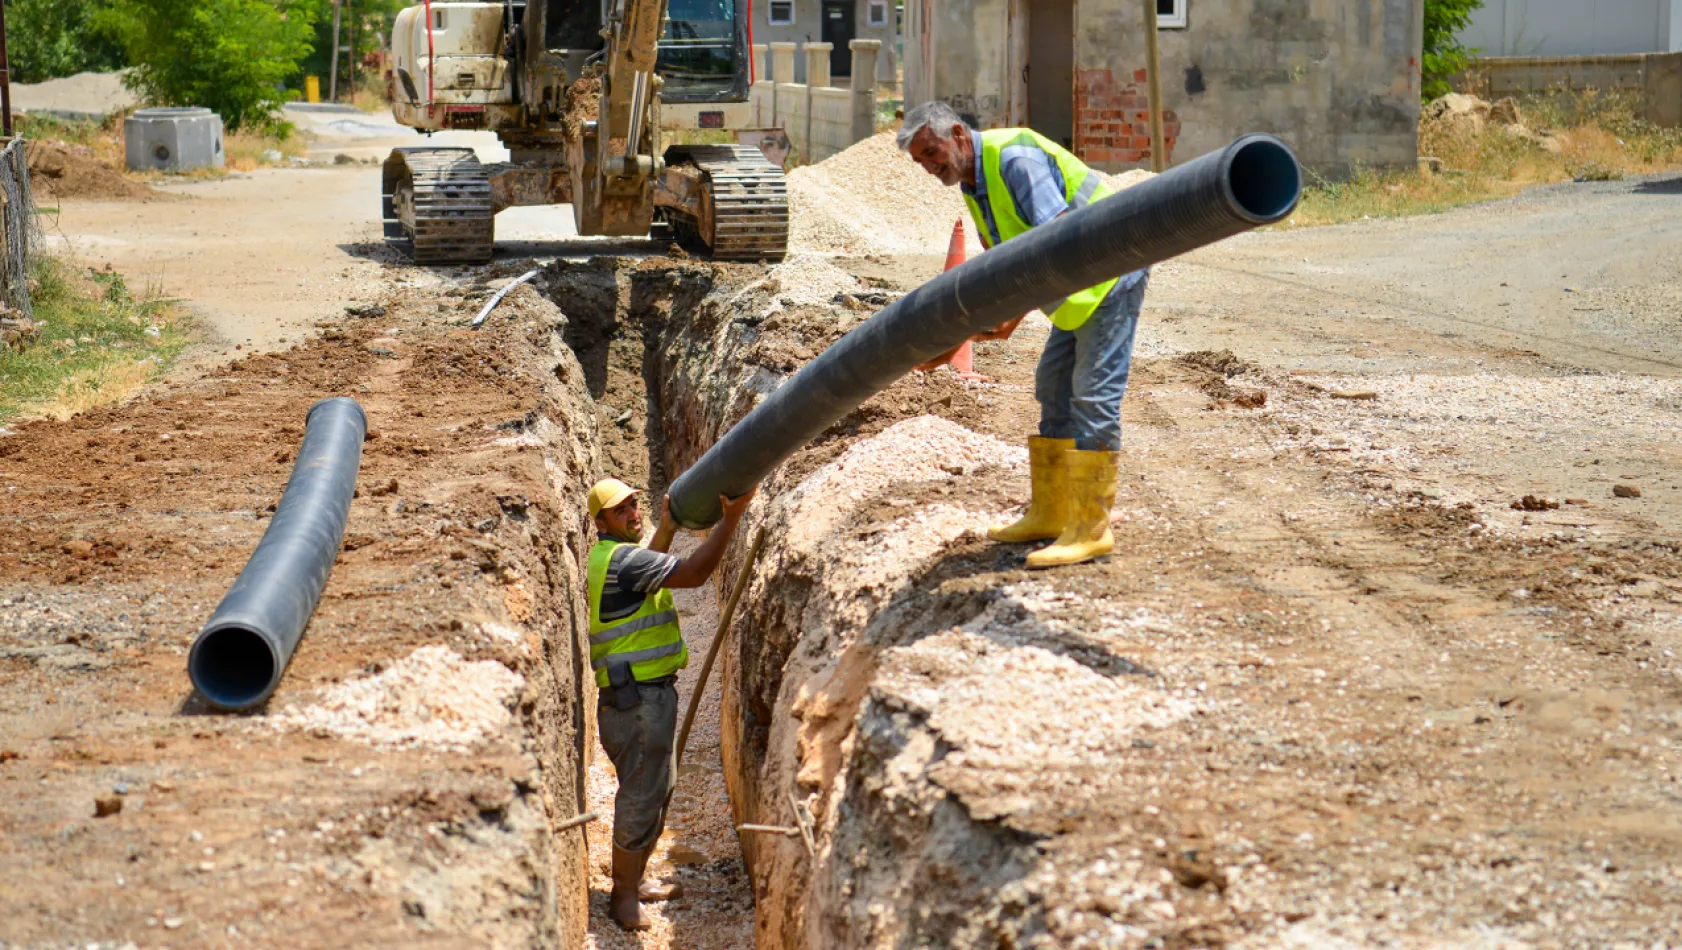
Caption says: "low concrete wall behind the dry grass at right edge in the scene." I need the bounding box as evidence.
[1475,52,1682,128]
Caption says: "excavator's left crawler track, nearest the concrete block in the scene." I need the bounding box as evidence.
[380,148,496,264]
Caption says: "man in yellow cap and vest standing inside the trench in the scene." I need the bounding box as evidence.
[589,478,754,930]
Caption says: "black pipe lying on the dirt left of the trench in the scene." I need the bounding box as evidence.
[187,397,368,710]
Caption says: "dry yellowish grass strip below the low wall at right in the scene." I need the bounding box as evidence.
[1285,91,1682,227]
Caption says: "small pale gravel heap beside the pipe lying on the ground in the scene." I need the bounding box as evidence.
[269,646,525,748]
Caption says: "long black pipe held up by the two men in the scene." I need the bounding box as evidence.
[669,135,1302,528]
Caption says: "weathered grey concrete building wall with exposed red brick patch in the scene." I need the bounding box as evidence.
[905,0,1425,175]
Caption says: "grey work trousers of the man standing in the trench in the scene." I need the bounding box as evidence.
[595,676,678,851]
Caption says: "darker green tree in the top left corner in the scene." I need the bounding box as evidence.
[5,0,128,82]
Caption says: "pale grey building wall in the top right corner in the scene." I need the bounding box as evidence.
[1460,0,1682,57]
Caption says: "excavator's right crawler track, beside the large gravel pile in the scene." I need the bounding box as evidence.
[666,145,789,261]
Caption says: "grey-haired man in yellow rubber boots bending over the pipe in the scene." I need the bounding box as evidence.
[897,103,1150,568]
